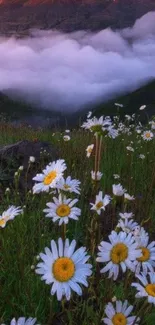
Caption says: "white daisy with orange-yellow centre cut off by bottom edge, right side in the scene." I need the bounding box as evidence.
[103,300,140,325]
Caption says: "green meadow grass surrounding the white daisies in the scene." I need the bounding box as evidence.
[0,117,155,325]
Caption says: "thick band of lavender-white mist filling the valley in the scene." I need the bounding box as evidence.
[0,12,155,112]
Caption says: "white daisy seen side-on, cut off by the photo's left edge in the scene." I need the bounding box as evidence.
[0,205,23,228]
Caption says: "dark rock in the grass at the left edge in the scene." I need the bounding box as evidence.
[0,140,58,190]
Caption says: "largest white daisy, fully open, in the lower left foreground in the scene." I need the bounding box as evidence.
[36,238,92,300]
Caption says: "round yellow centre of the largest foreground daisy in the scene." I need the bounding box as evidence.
[52,257,75,282]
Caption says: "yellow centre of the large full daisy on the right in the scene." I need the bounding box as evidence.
[110,243,128,264]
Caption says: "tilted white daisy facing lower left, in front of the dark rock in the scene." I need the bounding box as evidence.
[33,159,67,193]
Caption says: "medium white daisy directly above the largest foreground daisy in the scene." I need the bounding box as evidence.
[43,194,81,226]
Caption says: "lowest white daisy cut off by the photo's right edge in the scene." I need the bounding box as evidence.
[131,272,155,305]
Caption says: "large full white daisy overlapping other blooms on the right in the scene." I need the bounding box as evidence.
[96,231,141,280]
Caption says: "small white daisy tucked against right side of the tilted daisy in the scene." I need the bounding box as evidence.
[57,176,81,194]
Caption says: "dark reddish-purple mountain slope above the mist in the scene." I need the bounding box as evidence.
[0,0,155,36]
